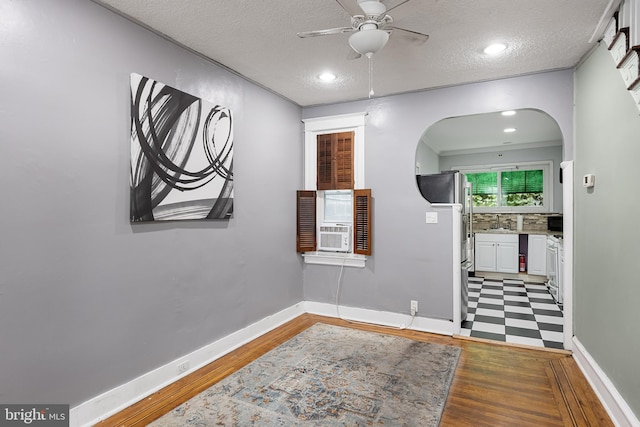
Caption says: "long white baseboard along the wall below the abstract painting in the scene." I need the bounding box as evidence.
[69,303,305,427]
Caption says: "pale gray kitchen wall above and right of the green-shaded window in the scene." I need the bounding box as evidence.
[440,145,562,212]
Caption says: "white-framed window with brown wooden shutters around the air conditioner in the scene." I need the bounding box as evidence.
[296,113,372,267]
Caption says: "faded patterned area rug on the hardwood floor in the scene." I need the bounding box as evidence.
[150,323,460,427]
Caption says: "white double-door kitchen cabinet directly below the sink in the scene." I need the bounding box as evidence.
[475,233,518,273]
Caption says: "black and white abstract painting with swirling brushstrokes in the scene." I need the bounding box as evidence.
[130,73,233,222]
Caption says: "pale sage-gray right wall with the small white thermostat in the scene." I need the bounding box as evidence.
[574,42,640,416]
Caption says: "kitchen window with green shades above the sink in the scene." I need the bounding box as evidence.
[462,162,553,212]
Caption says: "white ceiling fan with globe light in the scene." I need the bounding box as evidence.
[298,0,429,59]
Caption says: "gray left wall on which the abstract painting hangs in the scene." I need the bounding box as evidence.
[0,0,303,405]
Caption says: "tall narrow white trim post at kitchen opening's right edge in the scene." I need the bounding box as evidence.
[560,160,573,350]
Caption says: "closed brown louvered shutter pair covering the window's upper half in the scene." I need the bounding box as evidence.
[316,132,355,190]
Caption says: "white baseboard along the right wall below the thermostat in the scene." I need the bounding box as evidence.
[573,337,640,427]
